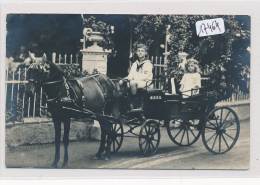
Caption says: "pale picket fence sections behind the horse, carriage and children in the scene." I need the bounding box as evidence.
[5,53,249,123]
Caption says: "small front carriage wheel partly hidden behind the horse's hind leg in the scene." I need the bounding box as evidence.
[111,123,124,153]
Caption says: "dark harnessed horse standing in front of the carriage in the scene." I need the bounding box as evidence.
[26,55,119,168]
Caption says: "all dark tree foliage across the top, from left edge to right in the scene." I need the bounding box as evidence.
[6,14,250,94]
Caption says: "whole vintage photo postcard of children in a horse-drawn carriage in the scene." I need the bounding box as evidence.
[5,13,251,170]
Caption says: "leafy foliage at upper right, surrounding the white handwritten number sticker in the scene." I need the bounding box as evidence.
[133,15,250,94]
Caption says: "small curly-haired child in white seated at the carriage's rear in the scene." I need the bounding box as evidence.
[180,59,201,98]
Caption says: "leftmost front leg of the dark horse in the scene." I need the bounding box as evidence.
[52,117,61,168]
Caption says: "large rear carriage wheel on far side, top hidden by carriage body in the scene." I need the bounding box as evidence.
[167,119,201,146]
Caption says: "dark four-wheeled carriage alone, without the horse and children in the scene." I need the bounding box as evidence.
[105,77,240,156]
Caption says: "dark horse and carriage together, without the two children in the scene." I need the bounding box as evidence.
[27,55,240,167]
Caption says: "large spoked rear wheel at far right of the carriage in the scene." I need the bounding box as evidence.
[202,107,240,154]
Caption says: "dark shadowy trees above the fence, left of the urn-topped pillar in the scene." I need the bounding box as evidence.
[6,14,83,57]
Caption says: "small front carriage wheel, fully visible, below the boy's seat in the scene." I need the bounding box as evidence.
[139,120,161,156]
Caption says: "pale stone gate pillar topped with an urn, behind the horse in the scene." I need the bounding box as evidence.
[81,28,111,74]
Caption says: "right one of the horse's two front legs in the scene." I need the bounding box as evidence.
[62,118,70,168]
